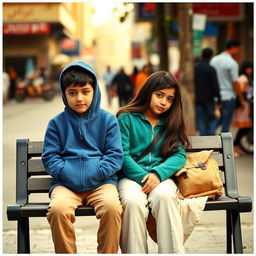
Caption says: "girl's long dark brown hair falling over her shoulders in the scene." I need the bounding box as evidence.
[117,71,190,157]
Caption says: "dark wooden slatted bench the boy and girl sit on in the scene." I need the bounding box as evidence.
[7,133,252,253]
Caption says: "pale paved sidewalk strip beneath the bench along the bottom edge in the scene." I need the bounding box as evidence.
[3,222,253,254]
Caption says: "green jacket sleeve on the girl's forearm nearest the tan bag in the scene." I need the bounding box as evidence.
[153,148,186,182]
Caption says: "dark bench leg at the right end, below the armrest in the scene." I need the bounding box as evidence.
[231,210,243,253]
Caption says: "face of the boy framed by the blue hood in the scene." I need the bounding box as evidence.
[65,83,94,116]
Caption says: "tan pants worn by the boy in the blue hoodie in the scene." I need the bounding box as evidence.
[47,184,122,253]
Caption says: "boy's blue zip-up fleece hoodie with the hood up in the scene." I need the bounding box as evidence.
[42,61,123,193]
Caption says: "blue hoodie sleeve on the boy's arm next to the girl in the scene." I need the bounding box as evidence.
[100,116,123,180]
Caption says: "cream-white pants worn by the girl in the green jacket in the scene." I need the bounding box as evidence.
[118,178,185,254]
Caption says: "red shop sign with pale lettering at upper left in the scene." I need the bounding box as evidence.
[3,23,50,35]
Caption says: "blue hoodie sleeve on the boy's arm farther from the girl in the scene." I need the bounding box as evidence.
[42,120,65,180]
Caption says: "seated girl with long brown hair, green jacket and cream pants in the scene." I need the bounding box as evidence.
[117,71,206,253]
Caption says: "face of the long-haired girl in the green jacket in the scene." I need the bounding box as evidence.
[148,88,175,116]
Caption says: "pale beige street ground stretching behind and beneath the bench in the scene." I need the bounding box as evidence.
[2,83,253,253]
